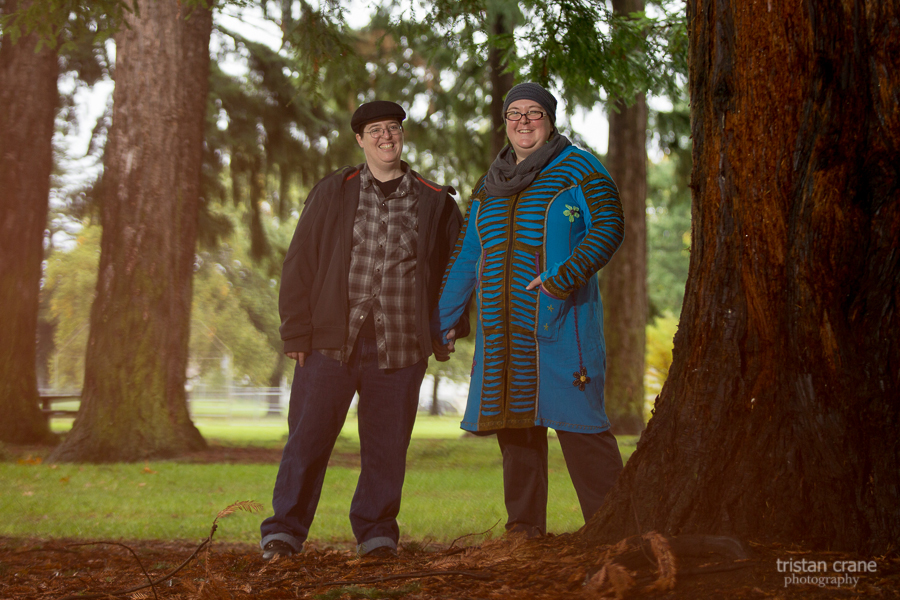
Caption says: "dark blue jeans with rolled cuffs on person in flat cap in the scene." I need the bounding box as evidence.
[260,339,427,554]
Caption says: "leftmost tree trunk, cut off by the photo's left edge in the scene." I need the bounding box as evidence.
[0,0,59,443]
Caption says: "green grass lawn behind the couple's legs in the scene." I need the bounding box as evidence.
[0,415,636,545]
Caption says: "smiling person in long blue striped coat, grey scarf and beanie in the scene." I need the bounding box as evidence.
[435,83,624,536]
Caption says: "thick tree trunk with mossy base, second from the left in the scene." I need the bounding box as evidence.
[51,0,212,462]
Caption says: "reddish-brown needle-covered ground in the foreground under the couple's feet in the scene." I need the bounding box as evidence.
[0,446,900,600]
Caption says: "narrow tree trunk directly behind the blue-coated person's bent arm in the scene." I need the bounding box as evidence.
[600,0,648,434]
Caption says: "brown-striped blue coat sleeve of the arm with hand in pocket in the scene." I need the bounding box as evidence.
[541,153,625,298]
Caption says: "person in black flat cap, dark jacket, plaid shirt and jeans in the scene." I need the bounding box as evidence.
[260,100,469,560]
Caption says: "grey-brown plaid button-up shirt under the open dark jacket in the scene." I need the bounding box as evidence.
[321,165,425,369]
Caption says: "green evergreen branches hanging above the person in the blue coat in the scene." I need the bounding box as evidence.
[410,0,687,110]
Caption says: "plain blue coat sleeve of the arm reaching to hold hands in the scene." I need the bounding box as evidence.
[432,200,481,344]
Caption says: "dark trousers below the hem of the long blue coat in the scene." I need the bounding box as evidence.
[497,427,622,537]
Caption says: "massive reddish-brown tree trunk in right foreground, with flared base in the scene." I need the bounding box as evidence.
[587,0,900,553]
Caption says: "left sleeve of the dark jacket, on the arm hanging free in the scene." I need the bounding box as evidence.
[278,177,330,352]
